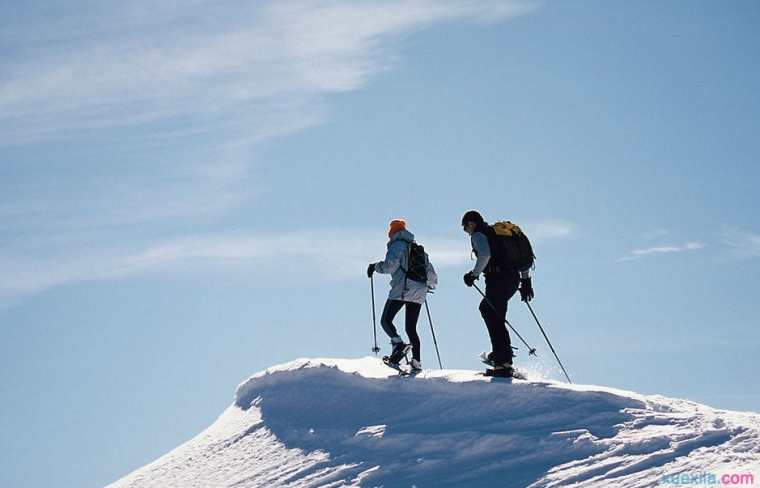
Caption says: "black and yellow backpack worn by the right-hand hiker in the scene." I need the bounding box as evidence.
[487,221,536,272]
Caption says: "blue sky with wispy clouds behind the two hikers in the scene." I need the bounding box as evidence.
[0,0,760,487]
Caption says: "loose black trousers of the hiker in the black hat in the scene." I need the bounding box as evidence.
[479,273,520,364]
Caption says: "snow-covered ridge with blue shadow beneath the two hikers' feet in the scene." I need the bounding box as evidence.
[110,357,760,488]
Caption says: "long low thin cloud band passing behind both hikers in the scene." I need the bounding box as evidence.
[0,219,567,300]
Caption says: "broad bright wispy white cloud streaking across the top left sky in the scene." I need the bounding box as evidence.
[0,0,531,144]
